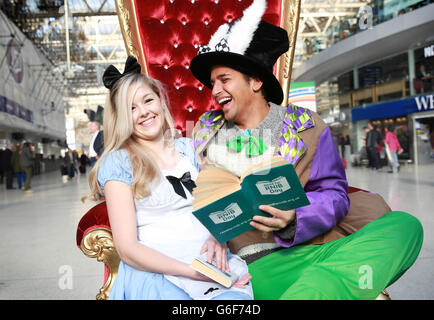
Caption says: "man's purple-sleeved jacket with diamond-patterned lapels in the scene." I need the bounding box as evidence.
[193,105,350,247]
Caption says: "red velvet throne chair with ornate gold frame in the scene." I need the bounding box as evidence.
[76,0,390,300]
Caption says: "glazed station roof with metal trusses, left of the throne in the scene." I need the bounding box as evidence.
[2,0,126,114]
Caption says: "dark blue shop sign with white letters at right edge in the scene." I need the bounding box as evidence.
[351,94,434,122]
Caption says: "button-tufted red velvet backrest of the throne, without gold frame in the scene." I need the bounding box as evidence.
[120,0,282,136]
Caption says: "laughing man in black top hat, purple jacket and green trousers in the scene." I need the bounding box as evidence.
[190,0,423,299]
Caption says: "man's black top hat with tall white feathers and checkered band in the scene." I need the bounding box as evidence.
[190,0,289,104]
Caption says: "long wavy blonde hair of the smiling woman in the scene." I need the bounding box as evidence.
[82,73,175,200]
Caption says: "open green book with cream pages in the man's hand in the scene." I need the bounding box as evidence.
[193,156,310,243]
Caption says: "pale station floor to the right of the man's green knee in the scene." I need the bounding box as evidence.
[347,163,434,300]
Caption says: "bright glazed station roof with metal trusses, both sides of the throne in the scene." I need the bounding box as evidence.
[2,0,369,120]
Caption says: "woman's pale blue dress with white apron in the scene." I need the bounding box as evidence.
[98,138,253,300]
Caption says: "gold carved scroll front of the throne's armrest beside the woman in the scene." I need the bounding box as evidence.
[80,227,120,300]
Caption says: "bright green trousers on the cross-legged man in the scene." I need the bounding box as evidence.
[249,211,423,300]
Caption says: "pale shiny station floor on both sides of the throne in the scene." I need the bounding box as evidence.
[0,164,434,299]
